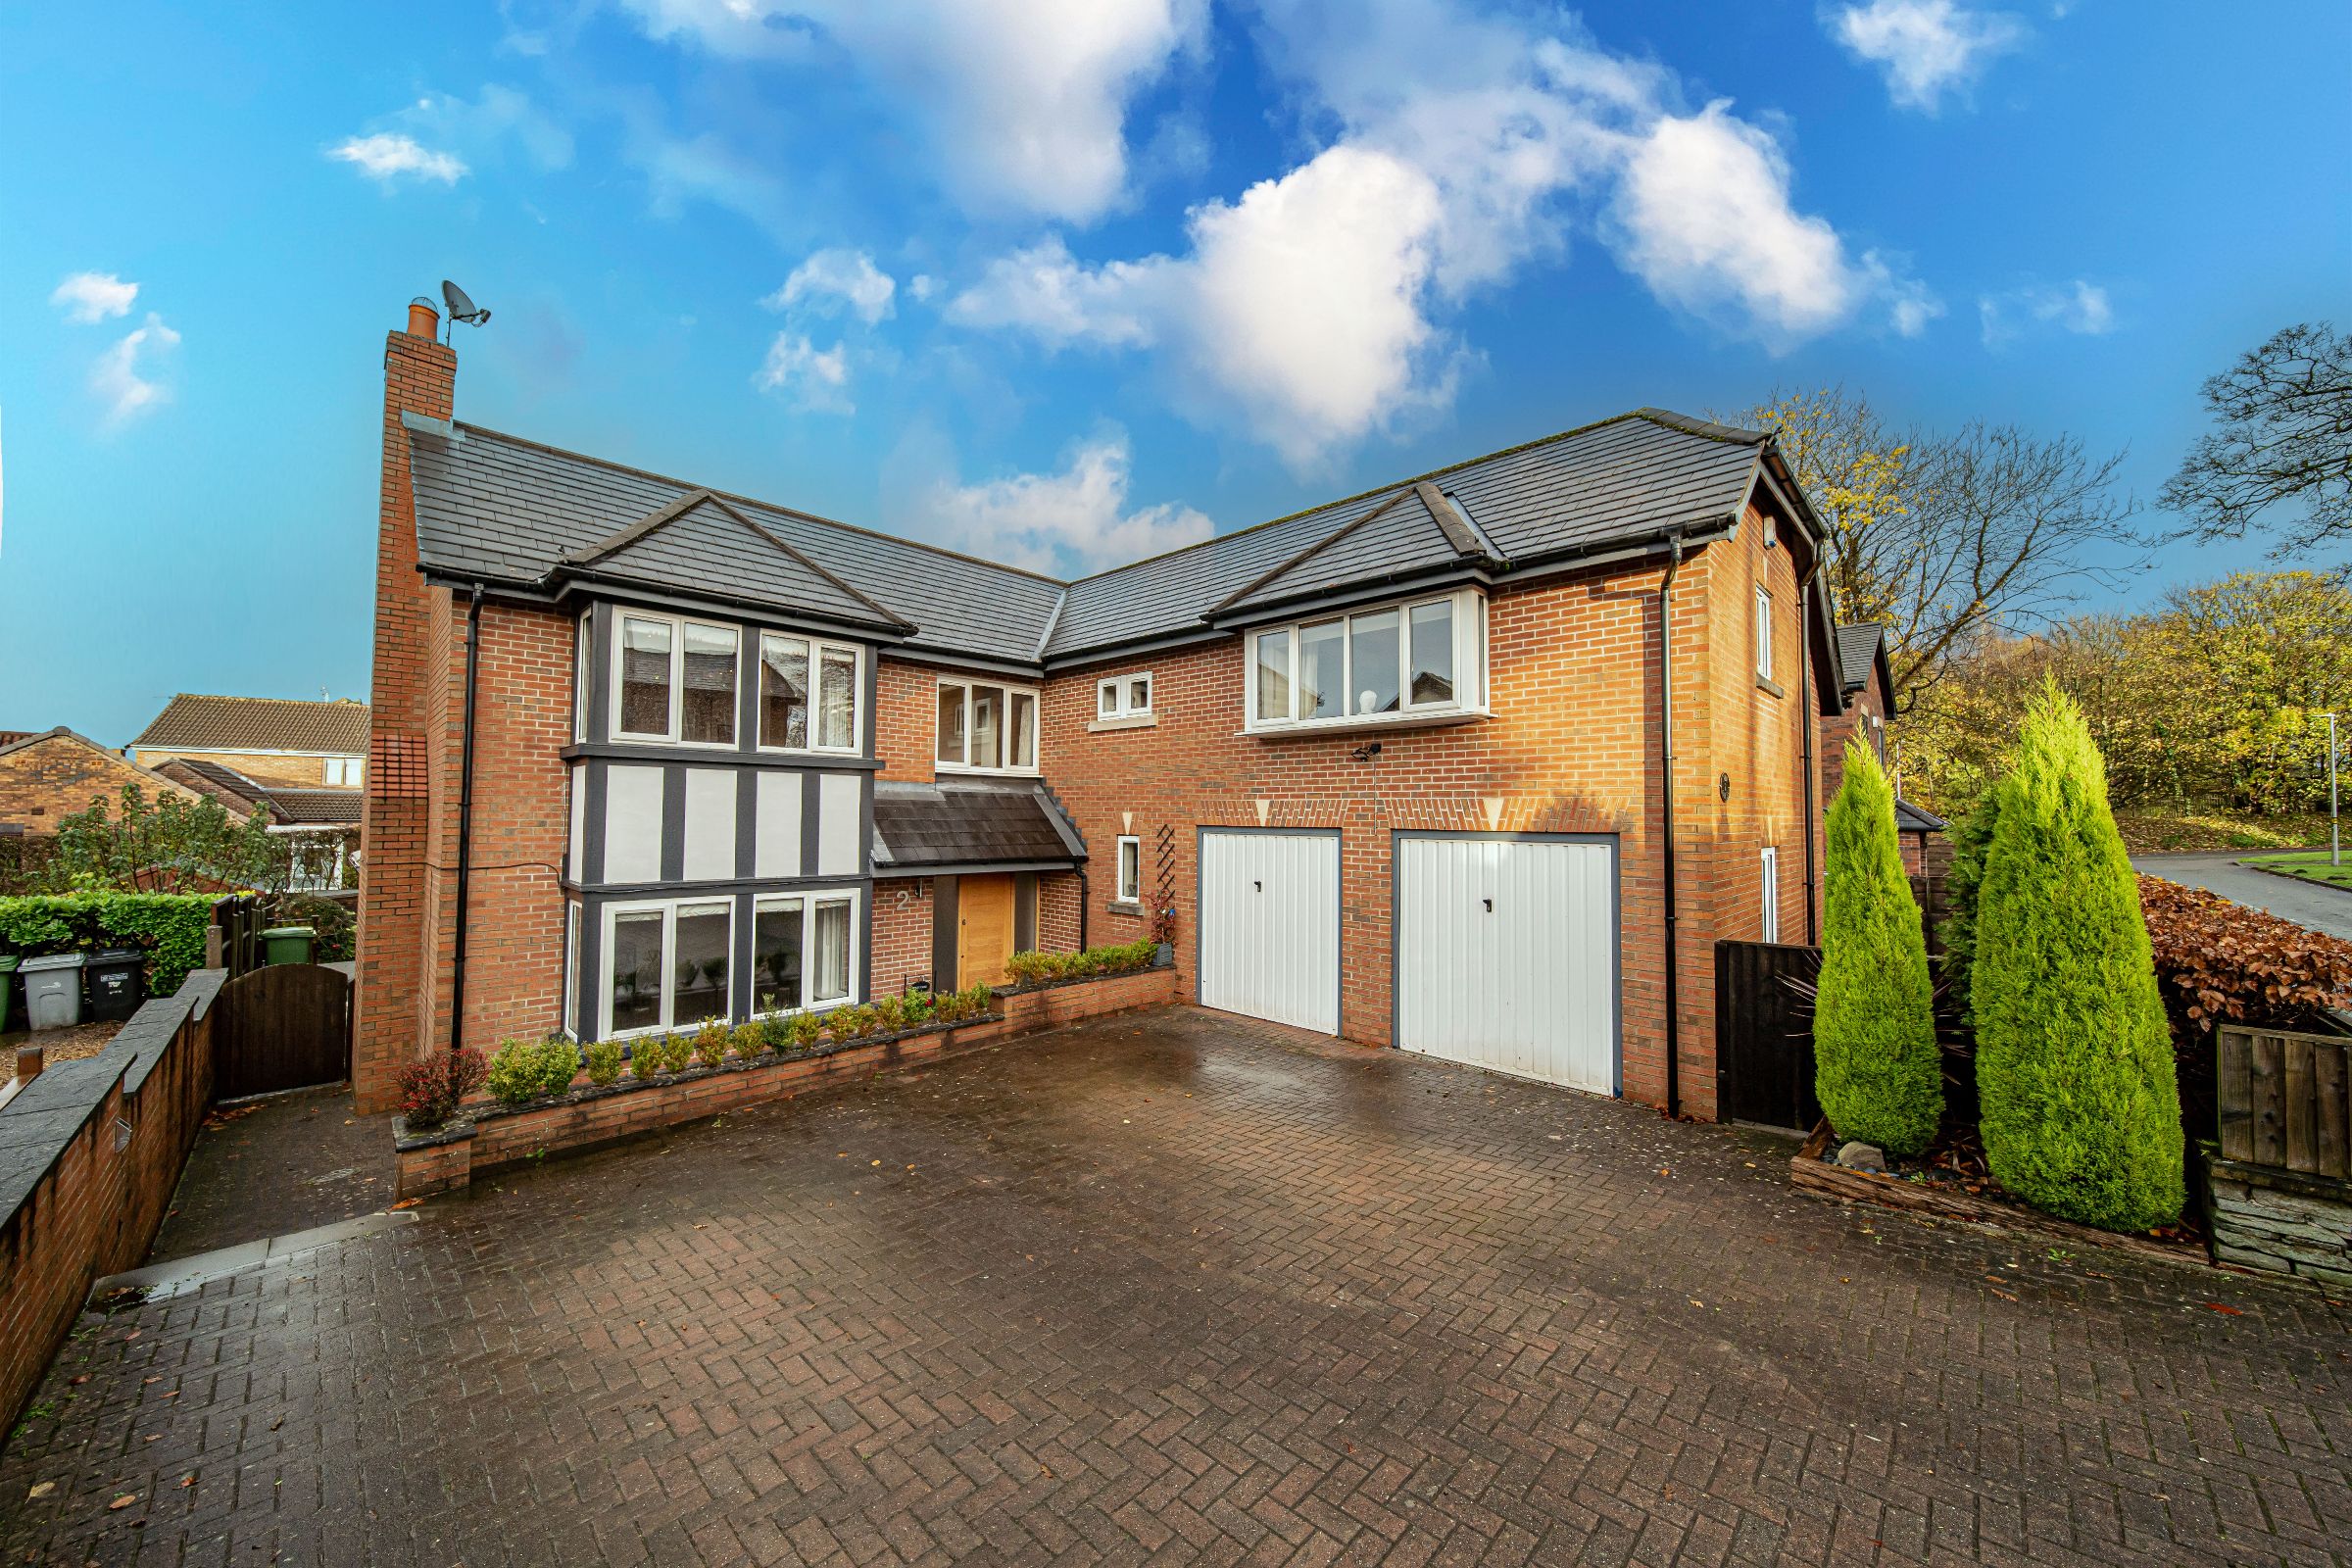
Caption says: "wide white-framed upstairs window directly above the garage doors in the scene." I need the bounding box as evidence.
[1245,590,1487,731]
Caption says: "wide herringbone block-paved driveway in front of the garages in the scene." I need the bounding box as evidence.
[0,1008,2352,1566]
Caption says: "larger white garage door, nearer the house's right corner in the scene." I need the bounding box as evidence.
[1397,837,1618,1093]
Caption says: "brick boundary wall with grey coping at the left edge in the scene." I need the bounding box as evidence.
[0,968,225,1425]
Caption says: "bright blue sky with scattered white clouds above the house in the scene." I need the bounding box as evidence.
[0,0,2352,745]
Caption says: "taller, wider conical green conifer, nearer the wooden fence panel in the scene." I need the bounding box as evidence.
[1969,682,2182,1230]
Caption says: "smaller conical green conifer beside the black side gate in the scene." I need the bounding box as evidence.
[1813,741,1942,1154]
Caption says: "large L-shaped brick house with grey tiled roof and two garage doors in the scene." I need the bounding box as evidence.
[355,303,1846,1116]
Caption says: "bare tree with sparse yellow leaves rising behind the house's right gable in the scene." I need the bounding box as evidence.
[1734,388,2147,708]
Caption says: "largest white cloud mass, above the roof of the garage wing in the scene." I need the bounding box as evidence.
[948,0,1942,467]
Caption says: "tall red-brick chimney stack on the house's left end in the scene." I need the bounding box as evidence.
[351,299,457,1114]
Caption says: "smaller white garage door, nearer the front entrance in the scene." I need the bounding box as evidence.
[1200,827,1339,1034]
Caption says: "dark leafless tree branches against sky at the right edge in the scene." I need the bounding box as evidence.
[2162,322,2352,555]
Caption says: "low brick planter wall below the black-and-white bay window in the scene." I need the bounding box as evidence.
[395,968,1195,1199]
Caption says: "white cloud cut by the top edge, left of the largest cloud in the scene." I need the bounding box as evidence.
[623,0,1209,220]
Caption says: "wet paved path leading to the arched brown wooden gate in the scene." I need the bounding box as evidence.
[148,1086,393,1262]
